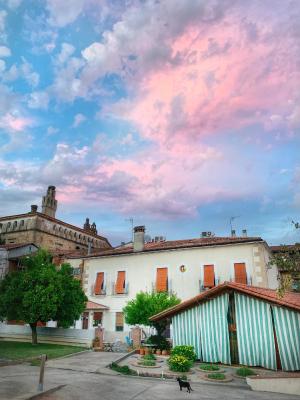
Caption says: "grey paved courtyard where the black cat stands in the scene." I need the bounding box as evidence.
[0,352,300,400]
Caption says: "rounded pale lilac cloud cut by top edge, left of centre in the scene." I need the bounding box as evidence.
[47,0,84,28]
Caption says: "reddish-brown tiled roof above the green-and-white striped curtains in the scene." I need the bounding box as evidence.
[150,282,300,321]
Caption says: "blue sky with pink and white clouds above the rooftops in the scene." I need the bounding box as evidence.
[0,0,300,244]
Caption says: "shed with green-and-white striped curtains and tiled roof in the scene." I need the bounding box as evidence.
[151,282,300,371]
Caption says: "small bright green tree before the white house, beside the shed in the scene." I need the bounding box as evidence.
[123,292,180,336]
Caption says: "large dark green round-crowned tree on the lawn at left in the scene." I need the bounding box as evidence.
[0,250,87,344]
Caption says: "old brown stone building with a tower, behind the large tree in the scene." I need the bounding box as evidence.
[0,186,111,254]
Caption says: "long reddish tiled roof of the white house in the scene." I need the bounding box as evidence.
[68,237,263,258]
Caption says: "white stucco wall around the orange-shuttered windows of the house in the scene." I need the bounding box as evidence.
[67,242,274,340]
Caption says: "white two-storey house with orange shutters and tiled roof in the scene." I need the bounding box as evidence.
[66,226,278,341]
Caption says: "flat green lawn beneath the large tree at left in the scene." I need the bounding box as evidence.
[0,341,87,360]
